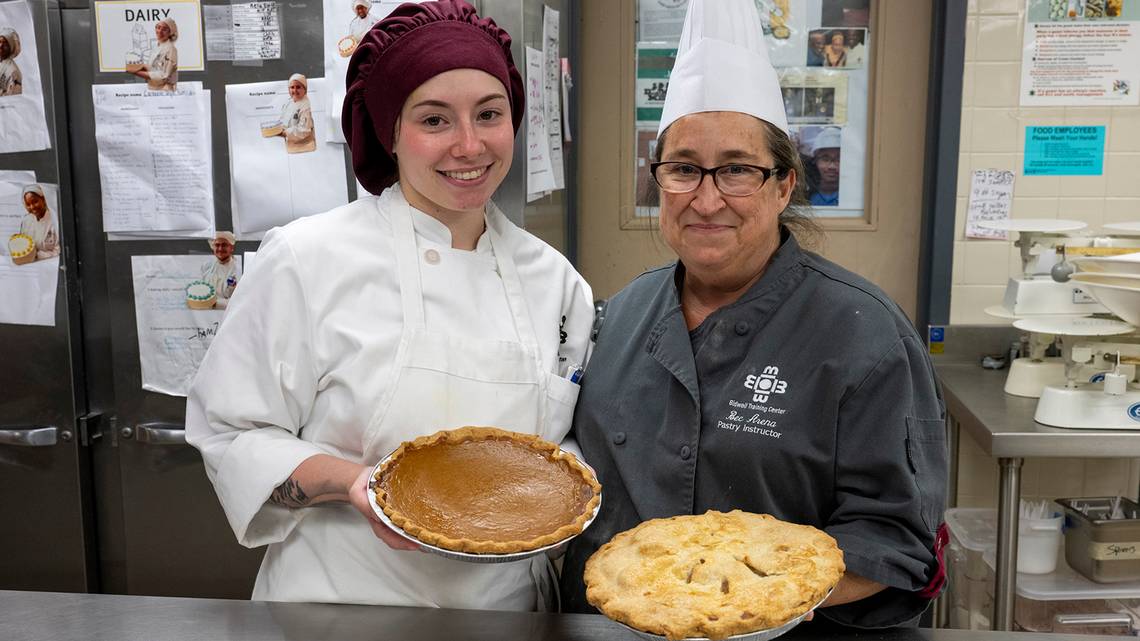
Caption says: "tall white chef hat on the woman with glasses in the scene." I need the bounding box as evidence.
[657,0,788,136]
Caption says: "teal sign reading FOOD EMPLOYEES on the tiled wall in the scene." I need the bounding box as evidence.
[1023,125,1105,176]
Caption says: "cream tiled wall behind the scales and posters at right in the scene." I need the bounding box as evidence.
[950,0,1140,506]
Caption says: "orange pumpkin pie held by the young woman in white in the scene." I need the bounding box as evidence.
[373,427,602,554]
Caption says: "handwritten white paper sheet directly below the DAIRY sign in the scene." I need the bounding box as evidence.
[91,83,214,235]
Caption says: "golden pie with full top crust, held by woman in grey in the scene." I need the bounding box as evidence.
[584,510,846,640]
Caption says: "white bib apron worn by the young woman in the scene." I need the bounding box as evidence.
[253,197,573,610]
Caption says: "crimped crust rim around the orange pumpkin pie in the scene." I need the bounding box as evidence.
[373,425,602,554]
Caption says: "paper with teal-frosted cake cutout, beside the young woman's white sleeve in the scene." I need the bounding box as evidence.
[131,253,242,396]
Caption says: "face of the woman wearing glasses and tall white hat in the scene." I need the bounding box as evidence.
[661,112,796,285]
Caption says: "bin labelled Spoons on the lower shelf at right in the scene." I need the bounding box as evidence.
[1057,496,1140,583]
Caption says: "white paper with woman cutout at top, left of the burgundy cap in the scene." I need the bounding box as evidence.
[226,74,349,238]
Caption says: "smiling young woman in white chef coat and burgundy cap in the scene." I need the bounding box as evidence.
[186,0,593,610]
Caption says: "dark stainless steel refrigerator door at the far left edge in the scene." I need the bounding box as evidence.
[0,1,98,592]
